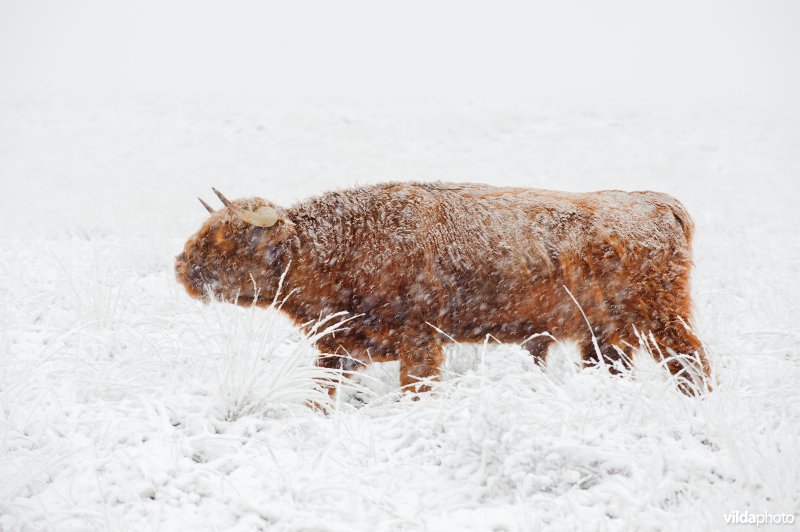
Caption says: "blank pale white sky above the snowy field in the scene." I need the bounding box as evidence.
[0,0,800,103]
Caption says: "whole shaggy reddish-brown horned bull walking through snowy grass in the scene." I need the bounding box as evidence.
[176,183,709,389]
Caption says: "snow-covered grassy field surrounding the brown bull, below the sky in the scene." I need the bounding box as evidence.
[0,98,800,531]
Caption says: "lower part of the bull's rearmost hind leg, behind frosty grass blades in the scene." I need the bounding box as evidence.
[650,321,712,395]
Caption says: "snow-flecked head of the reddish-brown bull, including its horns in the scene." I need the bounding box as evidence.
[175,189,295,305]
